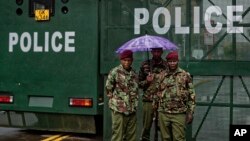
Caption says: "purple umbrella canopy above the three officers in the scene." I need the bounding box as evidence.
[116,34,178,53]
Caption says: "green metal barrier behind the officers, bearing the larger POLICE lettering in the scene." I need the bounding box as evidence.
[100,0,250,141]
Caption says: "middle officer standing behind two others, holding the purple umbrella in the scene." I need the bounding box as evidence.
[139,47,167,141]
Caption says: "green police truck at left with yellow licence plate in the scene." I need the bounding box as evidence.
[0,0,103,133]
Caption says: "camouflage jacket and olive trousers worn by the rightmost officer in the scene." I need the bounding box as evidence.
[157,68,195,141]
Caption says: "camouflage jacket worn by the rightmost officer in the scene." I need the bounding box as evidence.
[157,68,195,113]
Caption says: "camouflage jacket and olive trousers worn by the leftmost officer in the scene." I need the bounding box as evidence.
[106,65,138,141]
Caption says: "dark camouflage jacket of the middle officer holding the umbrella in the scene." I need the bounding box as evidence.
[139,59,167,101]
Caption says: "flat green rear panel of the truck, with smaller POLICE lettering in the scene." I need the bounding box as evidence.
[0,0,100,115]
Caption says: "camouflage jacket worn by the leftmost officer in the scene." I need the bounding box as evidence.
[106,65,139,115]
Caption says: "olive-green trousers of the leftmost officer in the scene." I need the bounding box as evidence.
[111,111,136,141]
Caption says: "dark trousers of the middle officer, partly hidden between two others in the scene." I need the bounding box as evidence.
[141,102,154,141]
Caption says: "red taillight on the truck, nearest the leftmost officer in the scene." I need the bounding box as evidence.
[69,98,93,107]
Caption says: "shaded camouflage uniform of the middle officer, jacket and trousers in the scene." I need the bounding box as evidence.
[139,59,167,141]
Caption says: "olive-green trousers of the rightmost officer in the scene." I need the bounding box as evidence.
[158,112,186,141]
